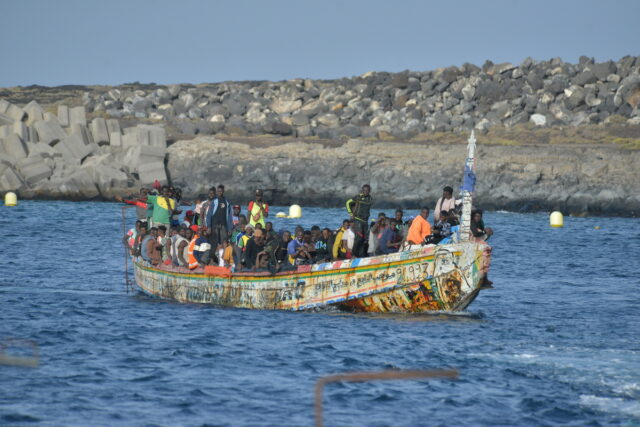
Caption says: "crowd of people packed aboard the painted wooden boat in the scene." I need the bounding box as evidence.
[117,184,493,273]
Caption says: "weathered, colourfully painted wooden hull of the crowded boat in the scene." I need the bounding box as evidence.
[134,242,491,313]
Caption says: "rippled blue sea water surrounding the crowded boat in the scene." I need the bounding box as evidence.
[0,202,640,426]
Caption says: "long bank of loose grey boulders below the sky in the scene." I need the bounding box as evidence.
[75,56,640,139]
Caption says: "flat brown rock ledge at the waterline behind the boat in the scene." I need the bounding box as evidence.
[167,137,640,215]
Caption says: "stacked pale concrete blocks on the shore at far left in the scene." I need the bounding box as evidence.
[0,100,167,200]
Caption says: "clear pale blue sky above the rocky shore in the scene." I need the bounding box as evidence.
[0,0,640,87]
